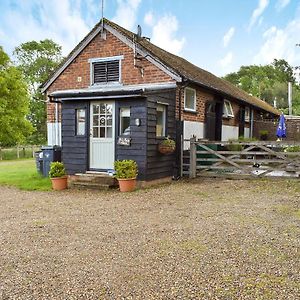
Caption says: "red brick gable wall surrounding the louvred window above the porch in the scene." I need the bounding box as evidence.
[47,32,173,122]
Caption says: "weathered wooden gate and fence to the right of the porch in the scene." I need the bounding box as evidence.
[182,138,300,178]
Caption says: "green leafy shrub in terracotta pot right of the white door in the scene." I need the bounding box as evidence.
[115,159,138,192]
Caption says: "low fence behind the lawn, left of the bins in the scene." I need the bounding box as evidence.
[0,145,41,160]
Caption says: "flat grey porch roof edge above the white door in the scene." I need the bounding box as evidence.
[49,82,176,101]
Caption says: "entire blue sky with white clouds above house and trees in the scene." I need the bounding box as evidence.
[0,0,300,75]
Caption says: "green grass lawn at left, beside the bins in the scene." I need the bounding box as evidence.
[0,159,51,191]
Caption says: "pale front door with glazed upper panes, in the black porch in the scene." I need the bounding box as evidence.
[90,101,115,169]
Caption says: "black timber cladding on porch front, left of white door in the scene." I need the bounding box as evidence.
[61,101,89,175]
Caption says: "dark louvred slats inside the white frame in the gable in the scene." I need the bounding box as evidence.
[93,60,120,84]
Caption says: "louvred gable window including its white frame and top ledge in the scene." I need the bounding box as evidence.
[89,56,123,85]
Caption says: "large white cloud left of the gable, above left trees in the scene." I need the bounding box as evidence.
[0,0,90,55]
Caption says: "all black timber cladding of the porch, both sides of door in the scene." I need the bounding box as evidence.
[62,89,176,180]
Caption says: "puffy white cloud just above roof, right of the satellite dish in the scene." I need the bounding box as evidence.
[151,14,185,55]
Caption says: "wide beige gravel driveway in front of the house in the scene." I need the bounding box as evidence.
[0,179,300,300]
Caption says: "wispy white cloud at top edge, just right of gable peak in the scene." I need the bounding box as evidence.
[112,0,141,30]
